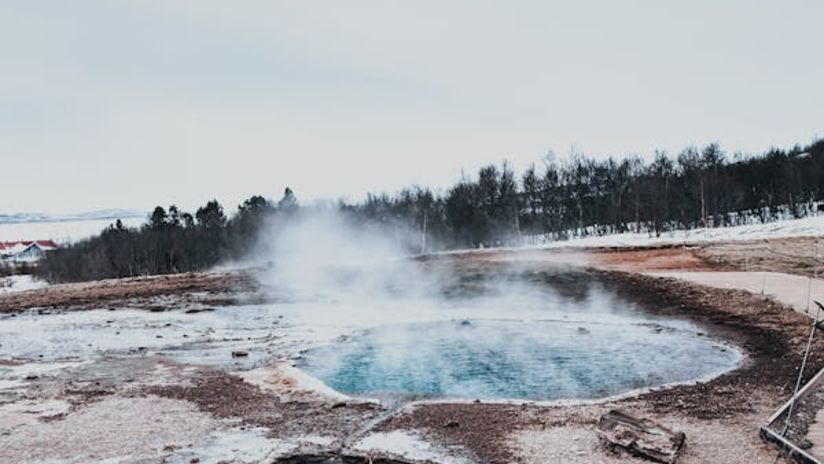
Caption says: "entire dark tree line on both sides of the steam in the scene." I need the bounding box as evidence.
[36,140,824,282]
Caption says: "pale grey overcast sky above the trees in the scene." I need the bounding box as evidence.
[0,0,824,213]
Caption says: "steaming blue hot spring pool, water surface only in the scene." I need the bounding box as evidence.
[300,318,742,400]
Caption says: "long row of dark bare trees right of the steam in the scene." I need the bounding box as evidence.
[338,140,824,251]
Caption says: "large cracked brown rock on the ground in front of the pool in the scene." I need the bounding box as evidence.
[596,409,686,464]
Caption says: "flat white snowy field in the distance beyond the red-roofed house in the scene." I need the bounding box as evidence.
[0,217,146,244]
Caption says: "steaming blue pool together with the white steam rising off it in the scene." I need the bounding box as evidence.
[268,213,741,399]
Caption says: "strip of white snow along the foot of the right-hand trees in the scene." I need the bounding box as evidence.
[539,215,824,248]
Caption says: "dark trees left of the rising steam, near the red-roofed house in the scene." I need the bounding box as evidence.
[35,189,297,282]
